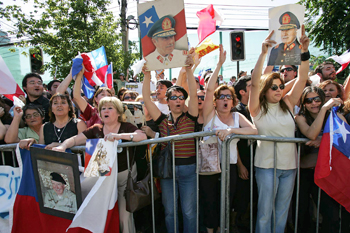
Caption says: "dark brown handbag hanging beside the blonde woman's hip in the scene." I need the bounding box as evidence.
[124,149,159,213]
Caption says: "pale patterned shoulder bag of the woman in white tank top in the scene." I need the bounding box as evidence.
[198,113,221,175]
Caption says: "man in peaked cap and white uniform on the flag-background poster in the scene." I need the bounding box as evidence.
[145,15,187,70]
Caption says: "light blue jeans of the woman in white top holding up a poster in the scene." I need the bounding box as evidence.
[255,167,296,233]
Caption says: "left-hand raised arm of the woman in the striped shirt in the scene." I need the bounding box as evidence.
[142,65,161,121]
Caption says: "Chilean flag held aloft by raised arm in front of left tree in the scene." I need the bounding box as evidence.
[72,46,108,86]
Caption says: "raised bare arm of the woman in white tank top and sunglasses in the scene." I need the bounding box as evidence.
[203,44,226,124]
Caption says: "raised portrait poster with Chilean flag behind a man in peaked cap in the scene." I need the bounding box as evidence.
[137,0,188,71]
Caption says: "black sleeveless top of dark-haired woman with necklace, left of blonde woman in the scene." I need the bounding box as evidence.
[44,118,78,145]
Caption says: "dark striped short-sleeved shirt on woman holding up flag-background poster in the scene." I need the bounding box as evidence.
[155,112,197,158]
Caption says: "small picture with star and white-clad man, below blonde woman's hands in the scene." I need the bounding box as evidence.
[84,138,118,177]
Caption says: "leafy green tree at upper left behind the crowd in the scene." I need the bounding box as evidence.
[0,0,138,79]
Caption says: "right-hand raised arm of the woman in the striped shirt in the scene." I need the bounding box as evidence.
[186,48,198,117]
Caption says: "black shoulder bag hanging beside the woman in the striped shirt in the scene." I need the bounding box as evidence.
[152,114,173,179]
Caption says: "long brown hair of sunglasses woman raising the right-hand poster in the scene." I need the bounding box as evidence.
[259,73,289,116]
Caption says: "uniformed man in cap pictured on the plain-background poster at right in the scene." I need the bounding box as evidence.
[267,11,301,66]
